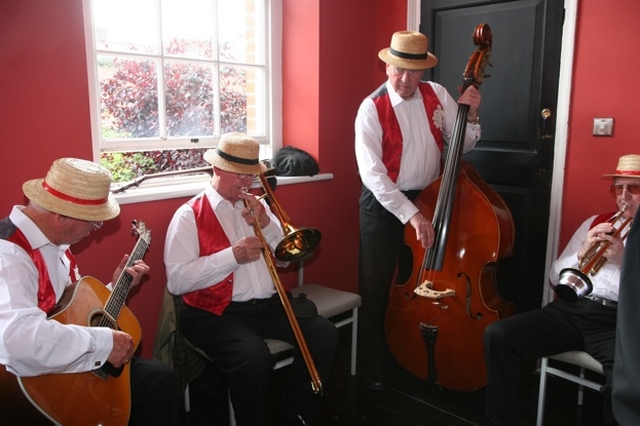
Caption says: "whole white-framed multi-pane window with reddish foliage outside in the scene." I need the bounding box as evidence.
[83,0,281,182]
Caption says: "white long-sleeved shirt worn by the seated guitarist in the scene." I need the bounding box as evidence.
[0,206,113,376]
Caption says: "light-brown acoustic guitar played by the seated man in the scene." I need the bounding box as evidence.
[0,221,151,426]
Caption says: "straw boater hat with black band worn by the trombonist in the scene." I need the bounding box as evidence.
[204,133,267,175]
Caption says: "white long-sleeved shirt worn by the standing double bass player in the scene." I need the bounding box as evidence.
[355,81,480,224]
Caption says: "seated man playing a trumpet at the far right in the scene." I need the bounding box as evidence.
[484,155,640,425]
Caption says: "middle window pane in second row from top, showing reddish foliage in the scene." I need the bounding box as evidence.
[164,61,214,136]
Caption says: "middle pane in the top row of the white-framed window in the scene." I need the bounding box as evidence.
[162,0,216,59]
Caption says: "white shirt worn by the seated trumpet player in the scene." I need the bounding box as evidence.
[549,215,626,302]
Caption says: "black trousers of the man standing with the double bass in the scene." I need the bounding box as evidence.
[358,186,420,369]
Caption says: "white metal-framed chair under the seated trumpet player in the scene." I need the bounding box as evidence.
[536,351,603,426]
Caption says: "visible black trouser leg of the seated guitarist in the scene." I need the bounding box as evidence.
[129,357,180,426]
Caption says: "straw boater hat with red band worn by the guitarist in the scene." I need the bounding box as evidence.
[22,158,120,222]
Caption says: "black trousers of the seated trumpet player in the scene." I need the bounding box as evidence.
[484,298,616,424]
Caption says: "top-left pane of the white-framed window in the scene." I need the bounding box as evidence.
[92,0,159,53]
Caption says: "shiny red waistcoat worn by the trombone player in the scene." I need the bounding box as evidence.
[182,194,233,315]
